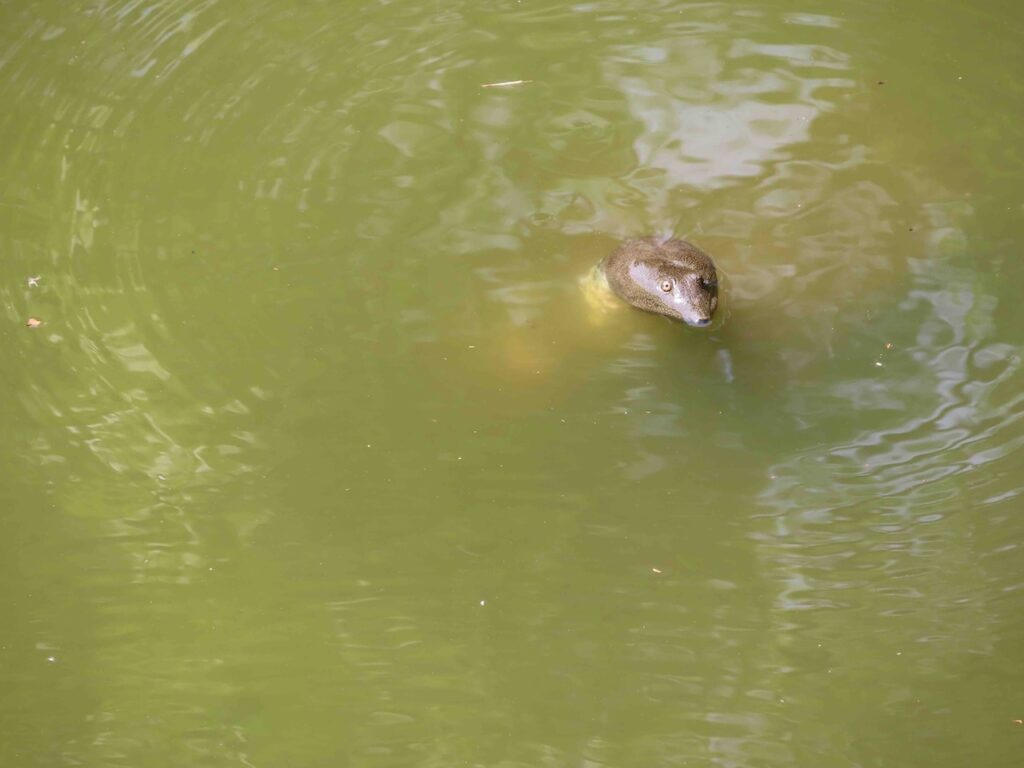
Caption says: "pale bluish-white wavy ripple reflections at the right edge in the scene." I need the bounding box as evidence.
[763,207,1021,522]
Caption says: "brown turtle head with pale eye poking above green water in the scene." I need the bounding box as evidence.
[598,238,718,328]
